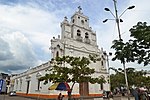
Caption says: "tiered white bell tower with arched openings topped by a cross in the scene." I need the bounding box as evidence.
[70,6,96,45]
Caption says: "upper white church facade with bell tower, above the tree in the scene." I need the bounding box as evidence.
[51,6,106,71]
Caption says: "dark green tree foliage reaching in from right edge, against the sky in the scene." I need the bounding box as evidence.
[112,22,150,66]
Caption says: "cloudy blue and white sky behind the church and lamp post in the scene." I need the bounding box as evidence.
[0,0,150,73]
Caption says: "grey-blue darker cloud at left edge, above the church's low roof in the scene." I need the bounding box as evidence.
[0,27,38,73]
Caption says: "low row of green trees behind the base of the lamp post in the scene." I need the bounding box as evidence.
[110,68,150,89]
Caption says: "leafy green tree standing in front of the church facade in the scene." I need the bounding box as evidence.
[40,55,105,99]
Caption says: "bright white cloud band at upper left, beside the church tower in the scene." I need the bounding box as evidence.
[0,5,60,52]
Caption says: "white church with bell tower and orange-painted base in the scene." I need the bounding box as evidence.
[10,7,110,98]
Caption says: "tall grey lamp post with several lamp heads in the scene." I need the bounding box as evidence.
[103,0,135,100]
